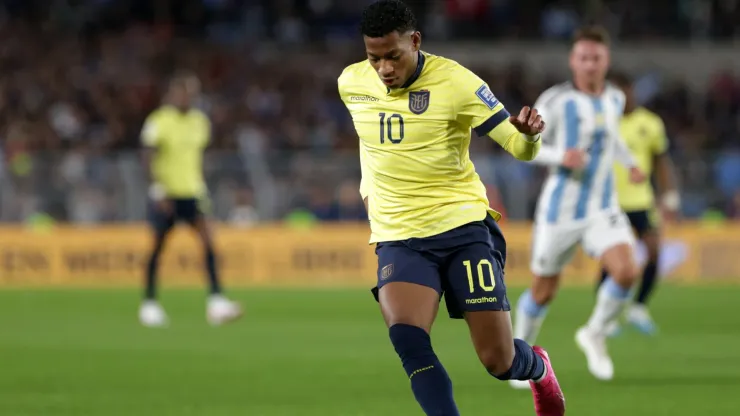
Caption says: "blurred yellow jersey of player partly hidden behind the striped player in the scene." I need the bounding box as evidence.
[614,107,668,212]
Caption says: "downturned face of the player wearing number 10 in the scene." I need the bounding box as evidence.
[365,31,421,88]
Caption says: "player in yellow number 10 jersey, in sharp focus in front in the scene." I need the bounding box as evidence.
[338,0,565,416]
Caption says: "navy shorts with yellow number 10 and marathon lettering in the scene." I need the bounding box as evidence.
[372,216,511,319]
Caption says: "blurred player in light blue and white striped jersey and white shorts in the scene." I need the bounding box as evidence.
[512,27,645,387]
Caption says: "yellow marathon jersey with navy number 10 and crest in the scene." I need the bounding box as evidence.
[338,52,540,243]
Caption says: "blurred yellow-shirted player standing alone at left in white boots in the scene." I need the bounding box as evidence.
[139,73,241,327]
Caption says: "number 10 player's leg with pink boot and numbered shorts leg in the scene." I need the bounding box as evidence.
[443,220,565,415]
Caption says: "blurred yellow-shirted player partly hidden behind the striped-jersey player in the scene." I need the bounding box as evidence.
[599,73,681,334]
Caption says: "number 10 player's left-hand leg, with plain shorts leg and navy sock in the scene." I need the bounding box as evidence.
[373,242,460,416]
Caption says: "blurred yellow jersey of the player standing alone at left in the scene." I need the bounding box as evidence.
[141,105,211,198]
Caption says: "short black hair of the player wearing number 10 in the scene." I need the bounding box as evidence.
[360,0,416,38]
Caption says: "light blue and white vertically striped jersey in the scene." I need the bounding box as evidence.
[534,82,634,223]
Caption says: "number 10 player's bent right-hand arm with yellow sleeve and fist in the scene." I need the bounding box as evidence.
[453,67,544,161]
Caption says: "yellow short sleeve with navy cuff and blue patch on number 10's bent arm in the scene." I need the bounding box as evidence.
[451,67,510,136]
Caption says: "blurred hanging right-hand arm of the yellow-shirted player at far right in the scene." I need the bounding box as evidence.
[652,119,681,214]
